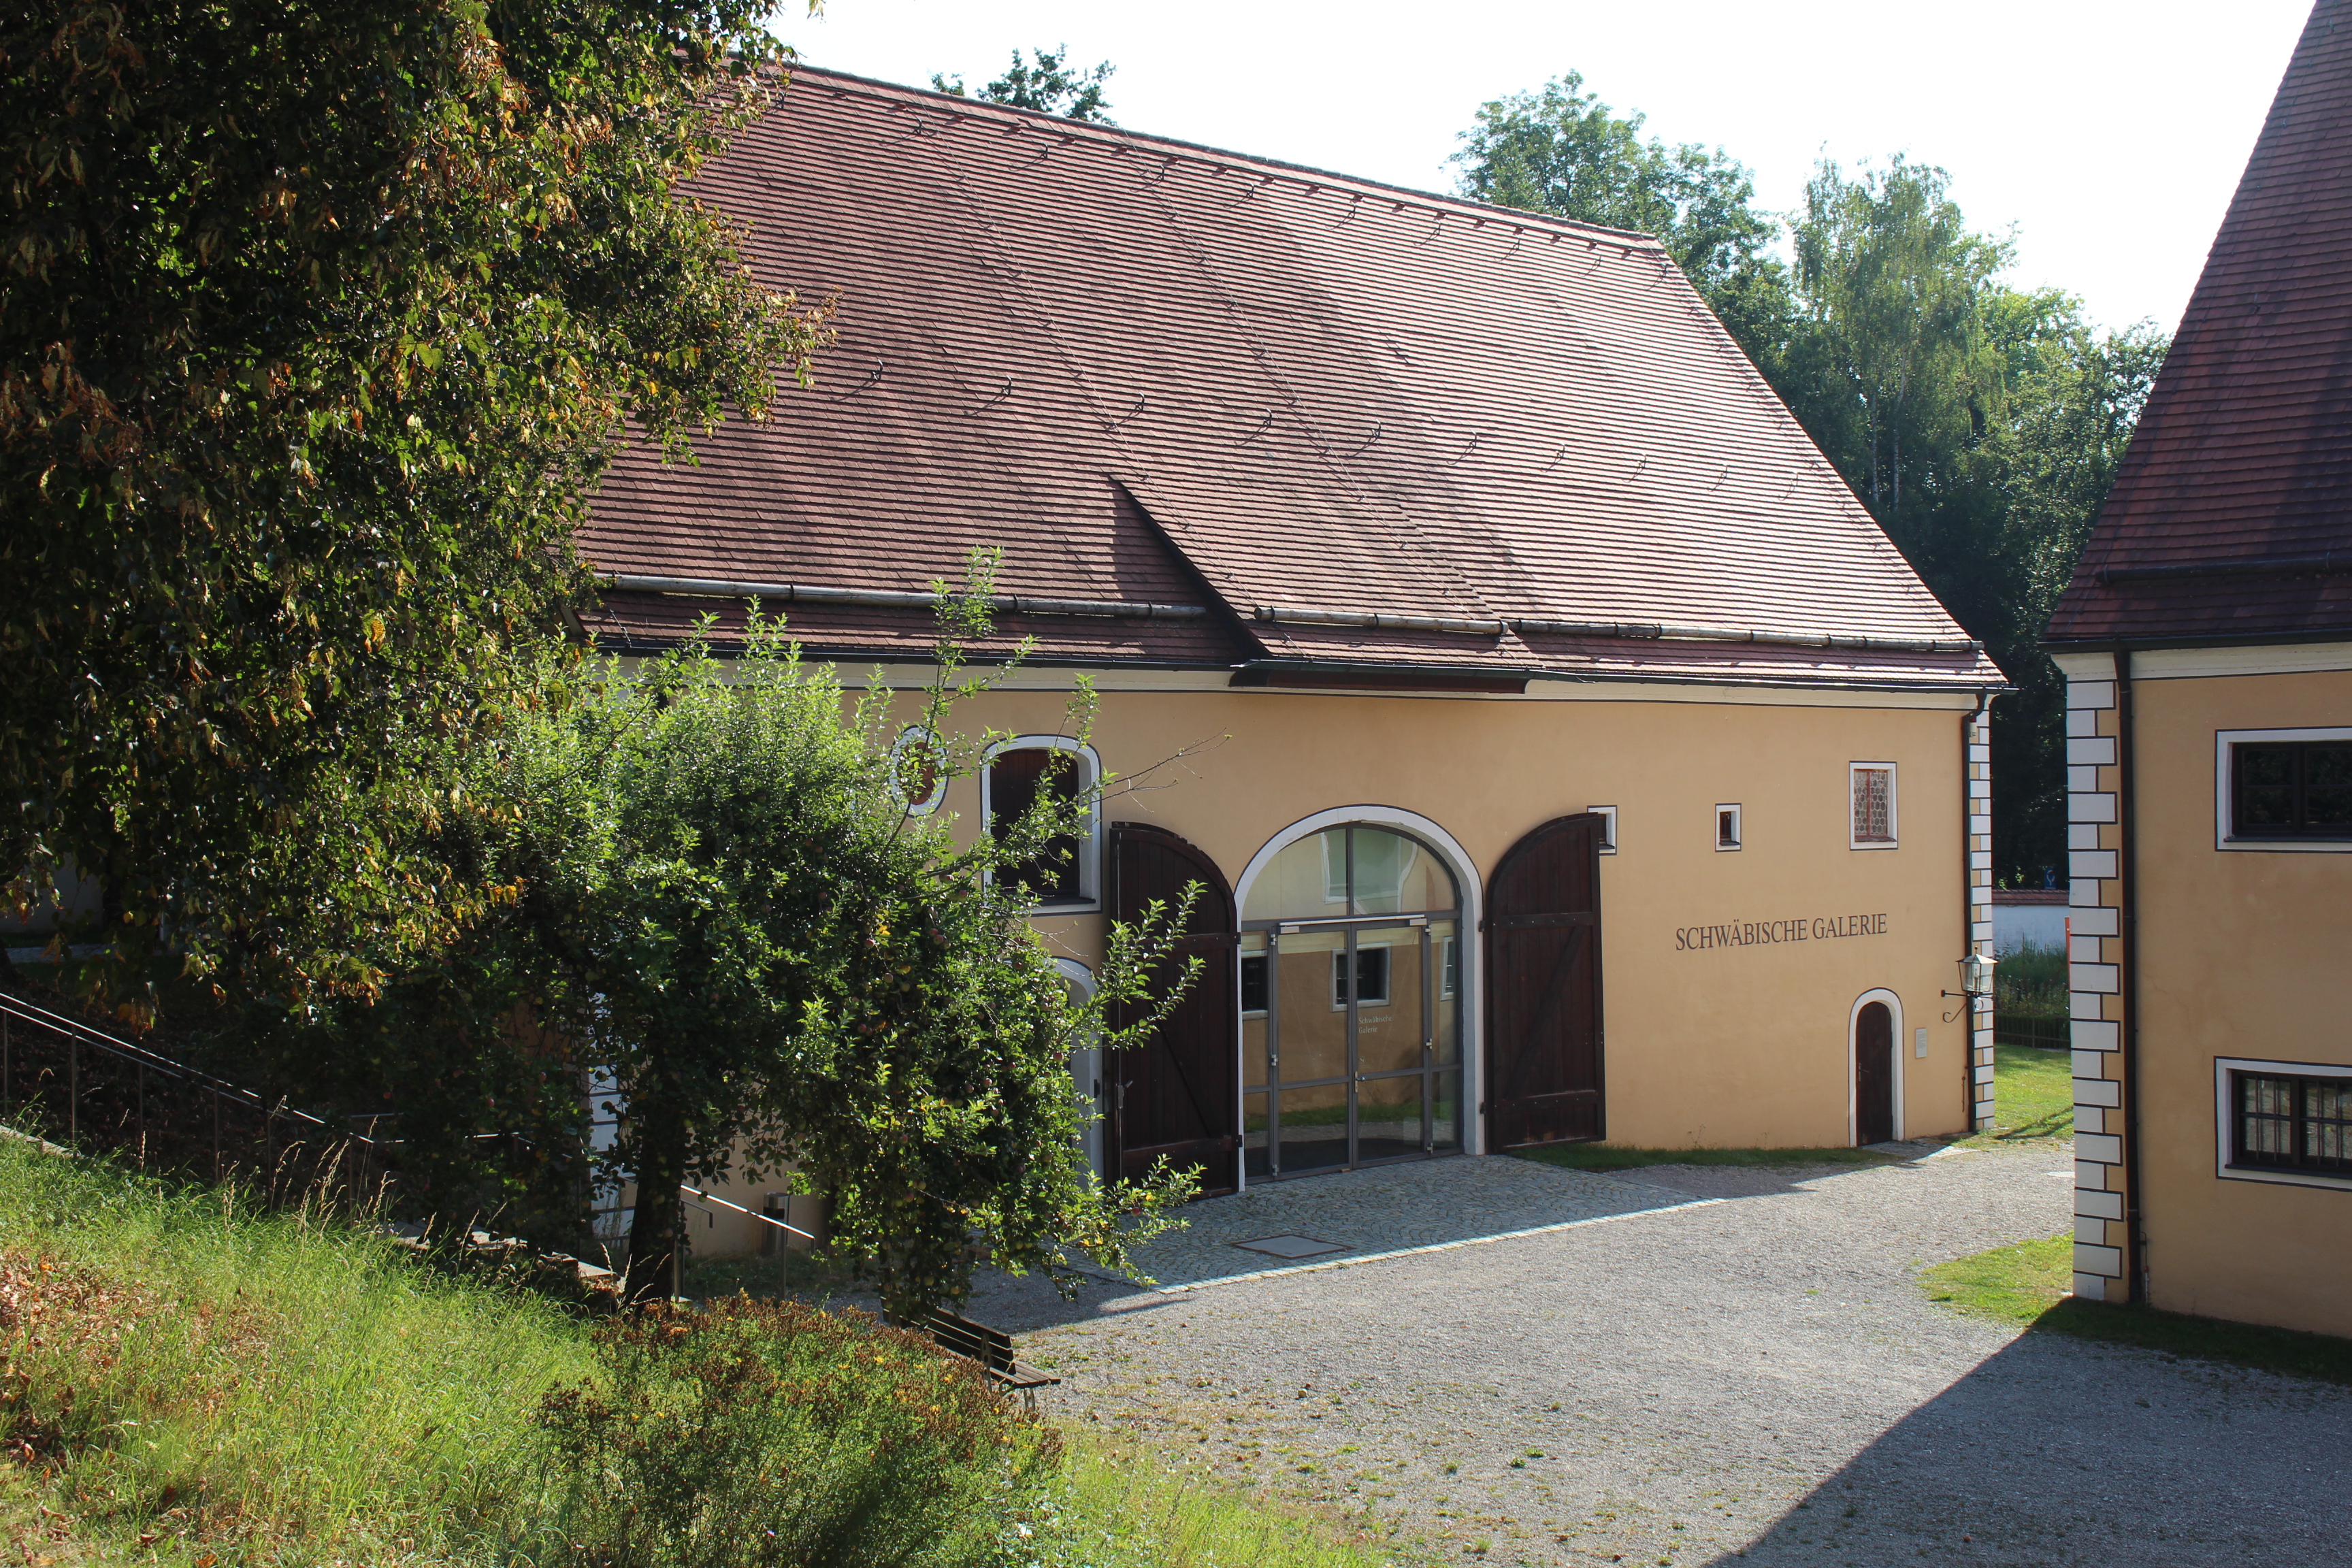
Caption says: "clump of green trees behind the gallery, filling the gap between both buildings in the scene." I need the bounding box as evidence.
[1456,73,2164,884]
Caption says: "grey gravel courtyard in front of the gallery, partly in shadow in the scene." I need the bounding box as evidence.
[971,1147,2352,1568]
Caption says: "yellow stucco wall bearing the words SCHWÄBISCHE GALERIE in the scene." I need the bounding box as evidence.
[694,672,1974,1256]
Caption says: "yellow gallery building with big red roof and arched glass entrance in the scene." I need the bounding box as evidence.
[581,71,2002,1250]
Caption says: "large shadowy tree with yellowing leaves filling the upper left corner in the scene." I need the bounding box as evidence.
[0,0,819,1011]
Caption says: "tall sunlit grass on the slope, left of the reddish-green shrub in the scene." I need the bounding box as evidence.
[0,1140,593,1561]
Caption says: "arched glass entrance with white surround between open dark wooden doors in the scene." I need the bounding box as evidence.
[1239,813,1465,1180]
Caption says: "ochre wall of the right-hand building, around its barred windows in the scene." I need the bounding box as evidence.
[2134,672,2352,1333]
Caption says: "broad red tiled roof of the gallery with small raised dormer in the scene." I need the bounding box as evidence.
[581,71,1999,687]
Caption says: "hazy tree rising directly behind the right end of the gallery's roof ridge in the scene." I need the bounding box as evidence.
[1454,71,1783,343]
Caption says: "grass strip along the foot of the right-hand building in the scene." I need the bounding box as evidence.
[1919,1237,2352,1385]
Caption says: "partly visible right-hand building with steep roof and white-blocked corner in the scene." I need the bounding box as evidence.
[2048,0,2352,1333]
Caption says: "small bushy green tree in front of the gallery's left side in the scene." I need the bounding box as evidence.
[261,562,1197,1311]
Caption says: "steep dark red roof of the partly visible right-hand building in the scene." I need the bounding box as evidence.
[2048,0,2352,644]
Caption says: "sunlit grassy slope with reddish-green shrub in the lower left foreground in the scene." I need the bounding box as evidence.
[0,1138,1392,1568]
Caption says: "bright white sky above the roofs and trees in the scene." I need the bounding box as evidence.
[776,0,2310,329]
